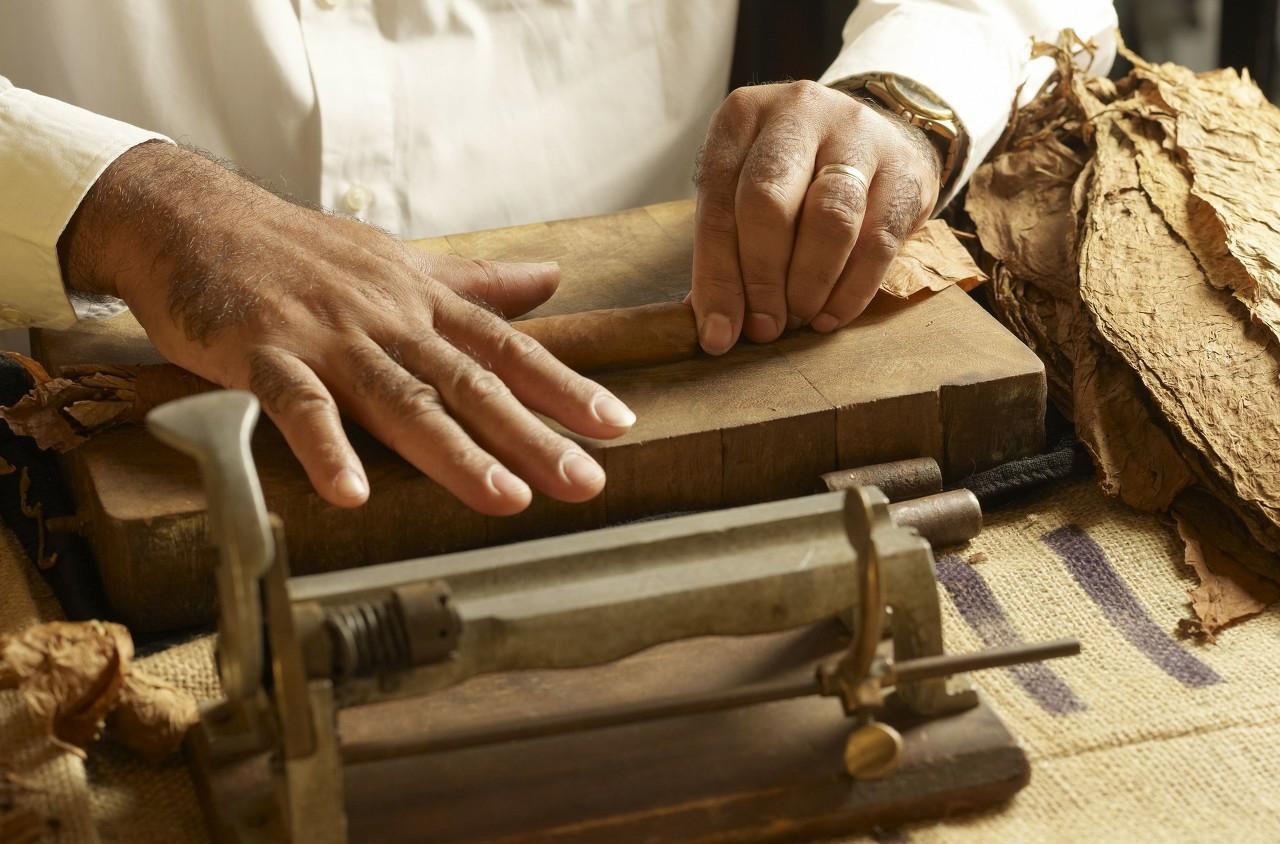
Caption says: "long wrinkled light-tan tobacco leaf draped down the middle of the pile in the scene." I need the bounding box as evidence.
[1079,122,1280,549]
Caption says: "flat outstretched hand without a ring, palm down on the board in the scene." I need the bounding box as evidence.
[59,143,635,515]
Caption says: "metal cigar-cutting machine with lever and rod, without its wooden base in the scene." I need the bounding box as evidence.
[147,391,1079,844]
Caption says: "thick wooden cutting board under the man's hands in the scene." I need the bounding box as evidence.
[33,201,1046,631]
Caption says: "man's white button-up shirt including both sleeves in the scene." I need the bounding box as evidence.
[0,0,1116,327]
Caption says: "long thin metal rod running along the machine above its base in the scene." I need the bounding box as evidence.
[342,639,1080,765]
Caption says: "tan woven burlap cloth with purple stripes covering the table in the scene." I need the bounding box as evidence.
[0,483,1280,843]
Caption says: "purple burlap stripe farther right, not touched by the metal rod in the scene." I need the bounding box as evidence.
[1044,525,1222,686]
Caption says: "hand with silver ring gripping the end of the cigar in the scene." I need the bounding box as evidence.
[691,82,940,355]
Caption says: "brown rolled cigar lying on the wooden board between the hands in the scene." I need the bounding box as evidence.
[511,302,698,373]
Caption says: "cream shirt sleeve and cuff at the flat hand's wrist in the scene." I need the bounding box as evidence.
[0,77,169,328]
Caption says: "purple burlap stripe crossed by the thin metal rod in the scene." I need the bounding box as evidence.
[934,555,1085,715]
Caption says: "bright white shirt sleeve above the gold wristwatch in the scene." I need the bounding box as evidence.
[819,0,1115,209]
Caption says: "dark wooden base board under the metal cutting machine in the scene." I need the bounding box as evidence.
[195,624,1029,844]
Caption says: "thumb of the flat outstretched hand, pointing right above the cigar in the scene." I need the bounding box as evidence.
[422,254,559,319]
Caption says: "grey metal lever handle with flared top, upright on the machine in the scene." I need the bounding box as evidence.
[147,389,275,701]
